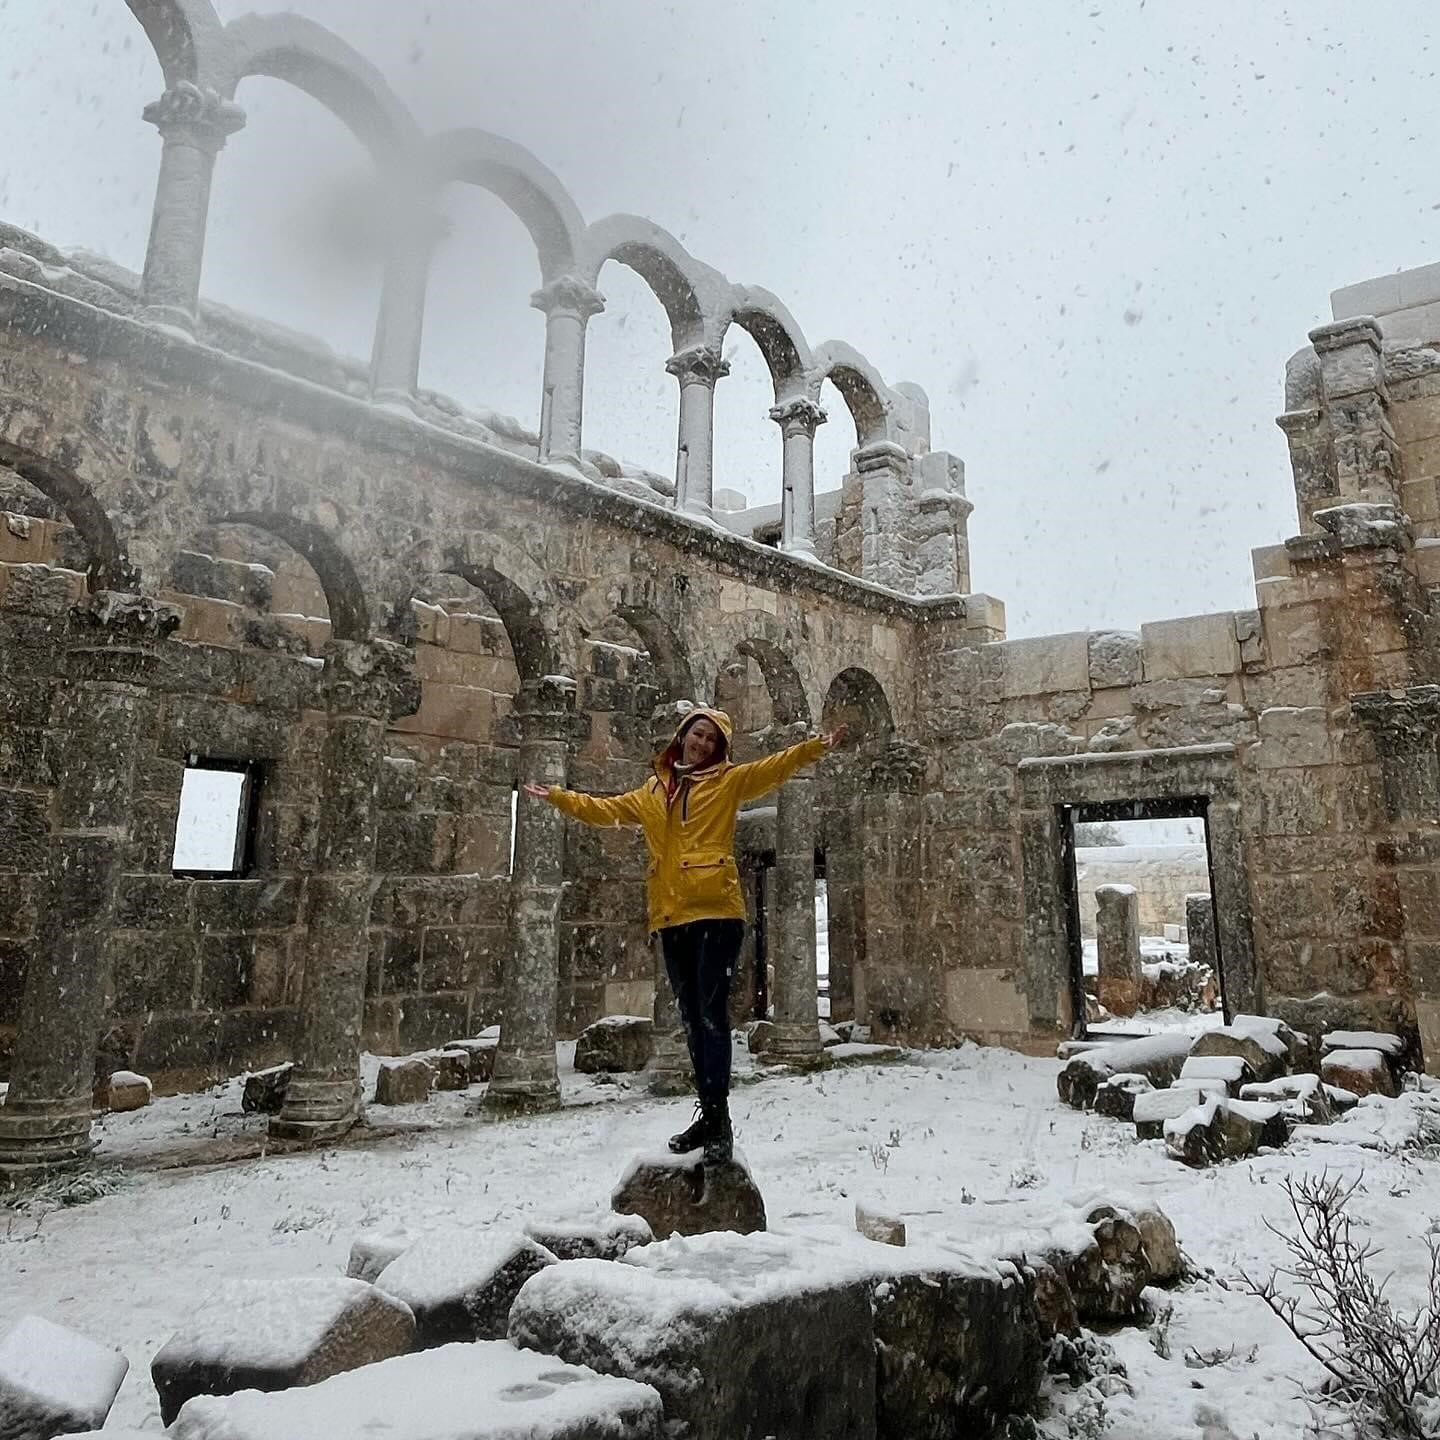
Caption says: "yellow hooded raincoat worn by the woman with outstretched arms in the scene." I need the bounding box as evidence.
[550,707,825,930]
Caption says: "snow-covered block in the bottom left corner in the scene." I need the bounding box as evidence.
[0,1315,130,1440]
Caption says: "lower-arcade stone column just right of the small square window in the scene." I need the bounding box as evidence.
[269,639,420,1142]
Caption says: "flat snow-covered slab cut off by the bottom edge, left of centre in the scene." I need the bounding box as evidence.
[167,1341,665,1440]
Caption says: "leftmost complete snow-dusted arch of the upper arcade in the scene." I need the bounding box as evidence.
[225,14,420,164]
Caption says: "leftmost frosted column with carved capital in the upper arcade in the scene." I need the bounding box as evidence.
[140,81,245,334]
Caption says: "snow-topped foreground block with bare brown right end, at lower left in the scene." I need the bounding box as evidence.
[150,1276,415,1424]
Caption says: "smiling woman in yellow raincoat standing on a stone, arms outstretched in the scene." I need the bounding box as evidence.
[526,707,845,1164]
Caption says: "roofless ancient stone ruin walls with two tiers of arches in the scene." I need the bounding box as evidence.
[0,0,1440,1168]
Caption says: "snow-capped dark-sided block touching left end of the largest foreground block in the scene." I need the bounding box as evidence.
[376,1230,556,1349]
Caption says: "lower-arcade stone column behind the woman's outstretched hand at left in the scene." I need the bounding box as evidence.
[484,675,575,1115]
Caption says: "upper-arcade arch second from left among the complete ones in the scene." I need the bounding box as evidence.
[425,130,585,284]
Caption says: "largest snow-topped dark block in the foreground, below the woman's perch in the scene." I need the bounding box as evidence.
[510,1236,875,1440]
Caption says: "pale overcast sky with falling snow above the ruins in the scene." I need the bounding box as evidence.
[0,0,1440,635]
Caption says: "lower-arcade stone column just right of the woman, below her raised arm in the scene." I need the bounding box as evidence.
[766,726,825,1066]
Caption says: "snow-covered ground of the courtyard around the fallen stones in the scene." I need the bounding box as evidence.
[0,1045,1440,1440]
